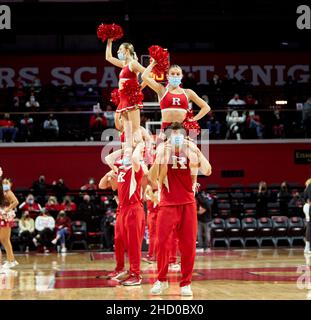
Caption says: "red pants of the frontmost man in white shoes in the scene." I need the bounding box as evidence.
[156,202,197,287]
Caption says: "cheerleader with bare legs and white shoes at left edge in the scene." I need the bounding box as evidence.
[0,168,18,269]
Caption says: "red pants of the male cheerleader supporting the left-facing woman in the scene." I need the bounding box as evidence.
[116,203,145,275]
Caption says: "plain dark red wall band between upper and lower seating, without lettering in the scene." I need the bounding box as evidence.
[0,142,311,189]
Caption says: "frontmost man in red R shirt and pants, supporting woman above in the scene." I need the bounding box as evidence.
[149,122,211,296]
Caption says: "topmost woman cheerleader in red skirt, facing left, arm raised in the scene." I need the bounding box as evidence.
[106,38,145,165]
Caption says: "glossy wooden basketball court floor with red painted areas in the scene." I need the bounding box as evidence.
[0,248,311,300]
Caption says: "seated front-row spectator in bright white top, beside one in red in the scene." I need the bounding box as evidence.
[33,209,55,253]
